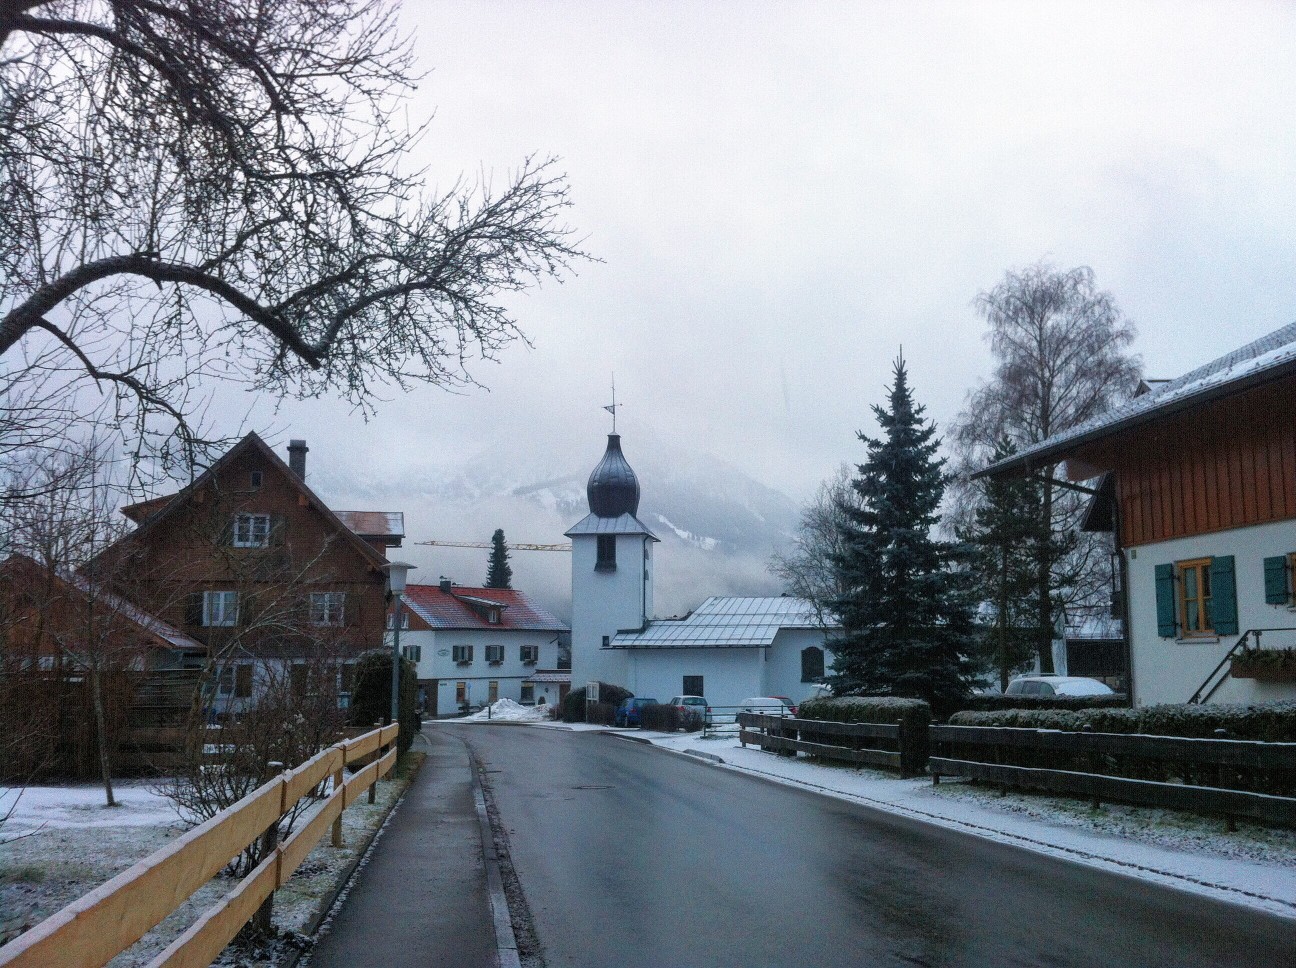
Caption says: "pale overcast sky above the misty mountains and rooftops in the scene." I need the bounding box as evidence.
[268,0,1296,515]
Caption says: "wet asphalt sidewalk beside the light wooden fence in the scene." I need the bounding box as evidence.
[302,730,495,968]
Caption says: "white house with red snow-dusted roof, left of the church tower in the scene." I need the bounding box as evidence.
[388,579,572,717]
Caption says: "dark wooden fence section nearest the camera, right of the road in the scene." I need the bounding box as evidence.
[927,726,1296,825]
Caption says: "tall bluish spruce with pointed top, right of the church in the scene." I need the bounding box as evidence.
[829,359,973,711]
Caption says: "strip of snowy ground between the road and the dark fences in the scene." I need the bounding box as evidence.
[531,723,1296,917]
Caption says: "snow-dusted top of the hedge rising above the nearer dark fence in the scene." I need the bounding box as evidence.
[950,702,1296,743]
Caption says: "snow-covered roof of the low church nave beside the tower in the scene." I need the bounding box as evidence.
[609,596,822,649]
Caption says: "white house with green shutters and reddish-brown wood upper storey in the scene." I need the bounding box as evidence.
[981,324,1296,705]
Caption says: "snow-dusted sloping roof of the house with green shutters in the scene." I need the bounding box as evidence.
[972,323,1296,478]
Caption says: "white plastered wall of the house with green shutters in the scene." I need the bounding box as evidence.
[1125,521,1296,705]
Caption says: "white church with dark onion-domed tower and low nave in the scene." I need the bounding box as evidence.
[566,433,832,706]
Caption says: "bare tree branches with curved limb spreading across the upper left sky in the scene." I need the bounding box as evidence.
[0,0,584,484]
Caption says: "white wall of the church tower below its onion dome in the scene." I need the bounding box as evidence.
[572,534,653,698]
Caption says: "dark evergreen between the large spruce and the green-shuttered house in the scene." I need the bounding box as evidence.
[958,438,1060,689]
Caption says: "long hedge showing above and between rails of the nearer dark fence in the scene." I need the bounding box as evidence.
[950,702,1296,797]
